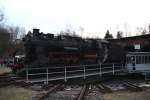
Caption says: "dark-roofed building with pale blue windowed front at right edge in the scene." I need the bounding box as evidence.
[108,34,150,74]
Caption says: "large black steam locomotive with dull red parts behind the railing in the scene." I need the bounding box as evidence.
[11,29,125,74]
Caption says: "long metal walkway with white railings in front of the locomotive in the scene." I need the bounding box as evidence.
[26,63,125,83]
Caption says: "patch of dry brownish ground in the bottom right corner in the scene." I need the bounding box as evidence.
[104,88,150,100]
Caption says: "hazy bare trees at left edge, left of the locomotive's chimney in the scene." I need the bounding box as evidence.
[0,11,25,56]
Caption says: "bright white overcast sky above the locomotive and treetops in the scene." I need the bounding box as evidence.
[0,0,150,38]
